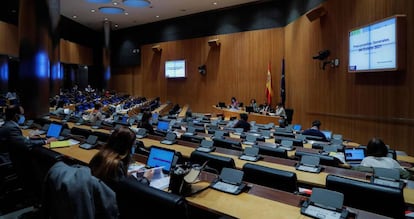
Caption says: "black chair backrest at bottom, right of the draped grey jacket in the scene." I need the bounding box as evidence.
[114,178,189,219]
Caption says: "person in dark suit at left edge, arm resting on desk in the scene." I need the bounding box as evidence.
[0,105,57,152]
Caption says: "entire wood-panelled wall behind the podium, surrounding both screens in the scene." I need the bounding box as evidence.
[113,0,414,156]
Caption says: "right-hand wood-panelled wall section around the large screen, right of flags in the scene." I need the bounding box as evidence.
[285,0,414,155]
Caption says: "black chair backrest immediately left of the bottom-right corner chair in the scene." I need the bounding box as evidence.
[242,163,298,193]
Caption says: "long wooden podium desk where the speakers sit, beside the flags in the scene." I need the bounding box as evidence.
[213,106,280,125]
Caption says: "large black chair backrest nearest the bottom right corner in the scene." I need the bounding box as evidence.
[326,175,405,219]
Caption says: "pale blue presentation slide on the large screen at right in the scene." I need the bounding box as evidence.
[349,18,397,71]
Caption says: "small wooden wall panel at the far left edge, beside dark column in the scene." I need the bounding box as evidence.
[0,21,19,57]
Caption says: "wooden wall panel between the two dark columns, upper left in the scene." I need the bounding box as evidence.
[60,39,93,65]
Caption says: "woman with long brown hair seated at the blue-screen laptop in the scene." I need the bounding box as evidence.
[89,126,153,188]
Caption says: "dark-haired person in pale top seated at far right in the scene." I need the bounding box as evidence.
[354,138,411,179]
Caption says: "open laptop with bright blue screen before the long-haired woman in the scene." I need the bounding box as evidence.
[147,146,175,172]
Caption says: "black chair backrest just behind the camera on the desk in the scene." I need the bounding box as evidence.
[190,151,236,173]
